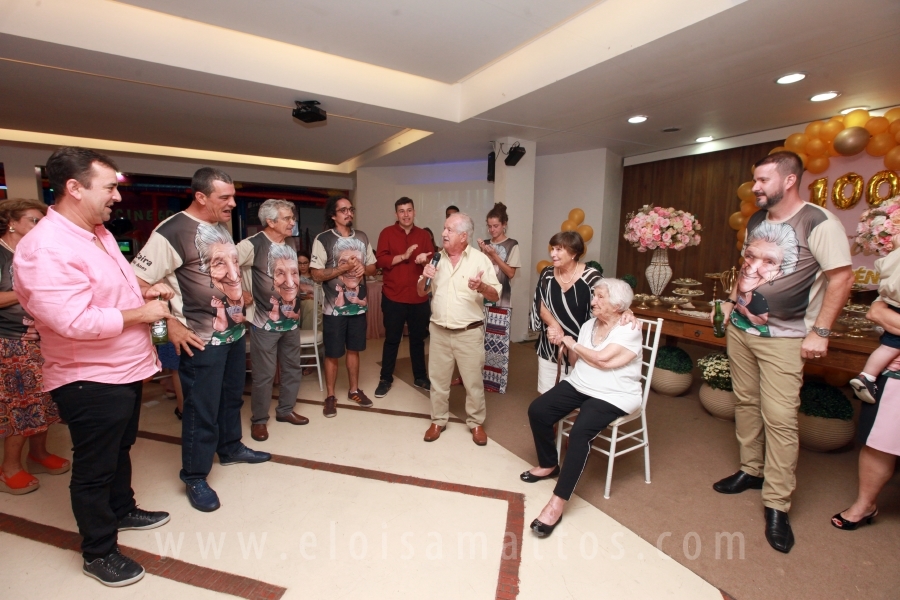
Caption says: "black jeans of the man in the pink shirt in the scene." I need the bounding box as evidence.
[50,381,143,560]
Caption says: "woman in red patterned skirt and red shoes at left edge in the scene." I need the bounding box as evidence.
[0,200,71,495]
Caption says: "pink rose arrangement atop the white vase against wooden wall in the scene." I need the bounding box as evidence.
[624,205,701,252]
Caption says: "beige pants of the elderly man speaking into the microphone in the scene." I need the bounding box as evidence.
[428,323,487,429]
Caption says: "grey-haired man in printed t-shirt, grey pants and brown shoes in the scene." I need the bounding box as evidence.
[237,200,309,442]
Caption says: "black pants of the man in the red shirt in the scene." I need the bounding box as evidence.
[381,294,431,382]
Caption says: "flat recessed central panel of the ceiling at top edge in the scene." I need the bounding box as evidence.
[119,0,600,83]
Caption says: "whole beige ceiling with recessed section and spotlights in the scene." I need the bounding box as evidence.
[0,0,900,168]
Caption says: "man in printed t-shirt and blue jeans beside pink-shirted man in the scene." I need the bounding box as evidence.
[131,167,271,512]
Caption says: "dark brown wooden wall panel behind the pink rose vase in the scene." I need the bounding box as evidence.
[616,142,784,300]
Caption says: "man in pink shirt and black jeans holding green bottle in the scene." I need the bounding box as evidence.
[13,148,174,587]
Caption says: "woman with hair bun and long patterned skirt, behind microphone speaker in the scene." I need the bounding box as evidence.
[478,202,522,394]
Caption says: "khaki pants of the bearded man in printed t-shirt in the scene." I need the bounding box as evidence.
[728,327,803,512]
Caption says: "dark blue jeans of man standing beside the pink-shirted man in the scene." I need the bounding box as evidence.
[178,337,247,482]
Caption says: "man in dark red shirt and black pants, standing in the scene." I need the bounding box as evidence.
[375,197,434,398]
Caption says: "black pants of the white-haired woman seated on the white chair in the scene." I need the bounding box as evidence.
[528,381,625,500]
